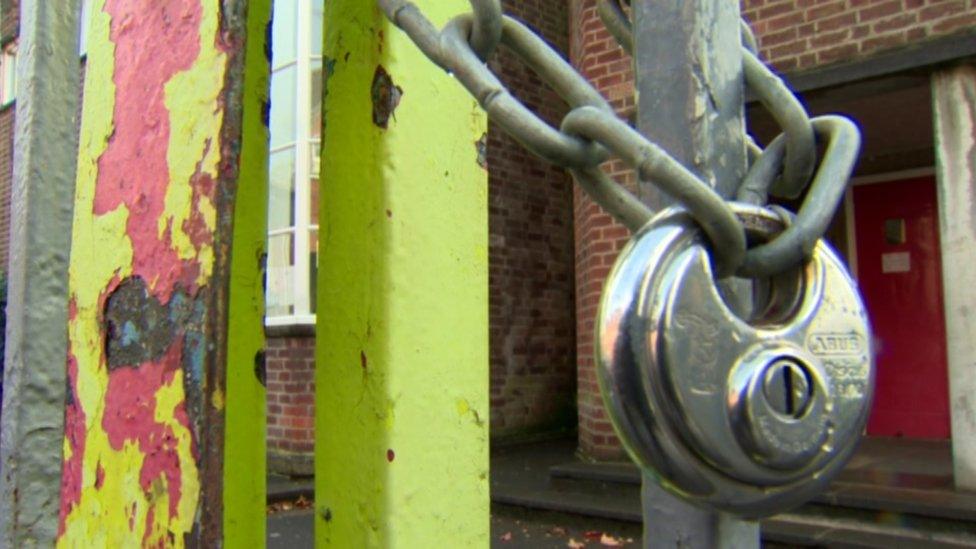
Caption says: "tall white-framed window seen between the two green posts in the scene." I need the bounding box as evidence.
[267,0,323,325]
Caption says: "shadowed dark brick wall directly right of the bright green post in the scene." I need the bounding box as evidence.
[487,0,576,440]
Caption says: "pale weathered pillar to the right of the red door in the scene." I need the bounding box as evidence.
[932,65,976,490]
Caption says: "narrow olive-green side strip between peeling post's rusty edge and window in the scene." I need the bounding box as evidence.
[223,0,271,549]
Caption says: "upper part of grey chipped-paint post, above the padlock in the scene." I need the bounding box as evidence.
[634,0,746,202]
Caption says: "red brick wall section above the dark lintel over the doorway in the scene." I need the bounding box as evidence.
[742,0,976,72]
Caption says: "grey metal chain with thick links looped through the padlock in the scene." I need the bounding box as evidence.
[378,0,859,276]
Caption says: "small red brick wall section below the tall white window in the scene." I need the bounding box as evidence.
[265,336,315,475]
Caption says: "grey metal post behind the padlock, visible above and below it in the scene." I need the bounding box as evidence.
[632,0,759,549]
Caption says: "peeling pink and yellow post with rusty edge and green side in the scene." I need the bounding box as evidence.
[58,0,269,547]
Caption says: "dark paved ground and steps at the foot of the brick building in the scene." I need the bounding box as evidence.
[267,439,964,549]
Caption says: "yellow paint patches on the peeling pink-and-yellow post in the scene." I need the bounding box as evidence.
[58,0,227,548]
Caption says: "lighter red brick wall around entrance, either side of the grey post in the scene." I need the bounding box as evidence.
[570,0,976,459]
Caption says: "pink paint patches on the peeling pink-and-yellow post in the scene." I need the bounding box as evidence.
[60,0,215,539]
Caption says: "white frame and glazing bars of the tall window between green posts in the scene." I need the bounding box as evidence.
[265,0,323,326]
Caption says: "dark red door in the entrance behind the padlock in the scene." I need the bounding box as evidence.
[854,176,949,439]
